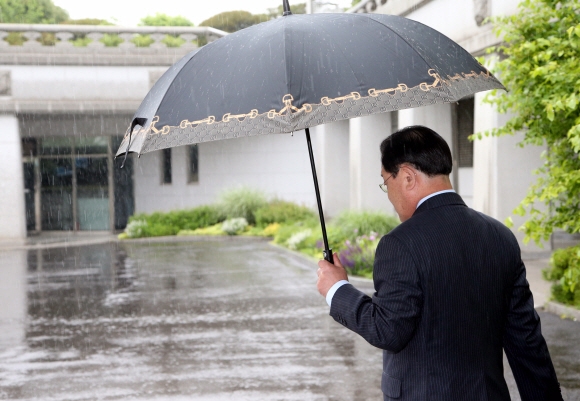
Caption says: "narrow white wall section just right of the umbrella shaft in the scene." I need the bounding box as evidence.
[310,120,350,217]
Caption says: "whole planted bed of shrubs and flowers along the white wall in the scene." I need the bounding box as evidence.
[119,188,398,277]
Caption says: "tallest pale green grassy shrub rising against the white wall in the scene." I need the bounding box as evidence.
[218,187,267,225]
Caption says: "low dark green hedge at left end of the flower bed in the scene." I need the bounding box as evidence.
[125,206,223,238]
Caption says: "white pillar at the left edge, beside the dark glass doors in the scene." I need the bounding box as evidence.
[0,116,26,241]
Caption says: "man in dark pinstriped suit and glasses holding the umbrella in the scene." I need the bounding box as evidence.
[318,126,562,401]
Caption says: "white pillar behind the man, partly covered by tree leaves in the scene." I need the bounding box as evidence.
[473,93,549,251]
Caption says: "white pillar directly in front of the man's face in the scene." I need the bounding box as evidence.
[349,113,395,214]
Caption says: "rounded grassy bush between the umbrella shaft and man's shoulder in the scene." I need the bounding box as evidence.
[332,210,399,241]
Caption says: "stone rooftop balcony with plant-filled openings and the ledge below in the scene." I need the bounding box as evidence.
[0,24,227,66]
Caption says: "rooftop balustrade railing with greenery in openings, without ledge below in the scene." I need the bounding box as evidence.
[0,24,227,49]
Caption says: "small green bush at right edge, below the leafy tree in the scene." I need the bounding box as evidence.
[542,246,580,308]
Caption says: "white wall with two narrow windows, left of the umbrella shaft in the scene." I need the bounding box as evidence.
[135,131,316,212]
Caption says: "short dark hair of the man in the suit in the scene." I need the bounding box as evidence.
[381,125,453,177]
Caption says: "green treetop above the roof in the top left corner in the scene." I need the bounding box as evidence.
[0,0,69,24]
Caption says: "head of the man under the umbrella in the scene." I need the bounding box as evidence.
[381,125,453,221]
